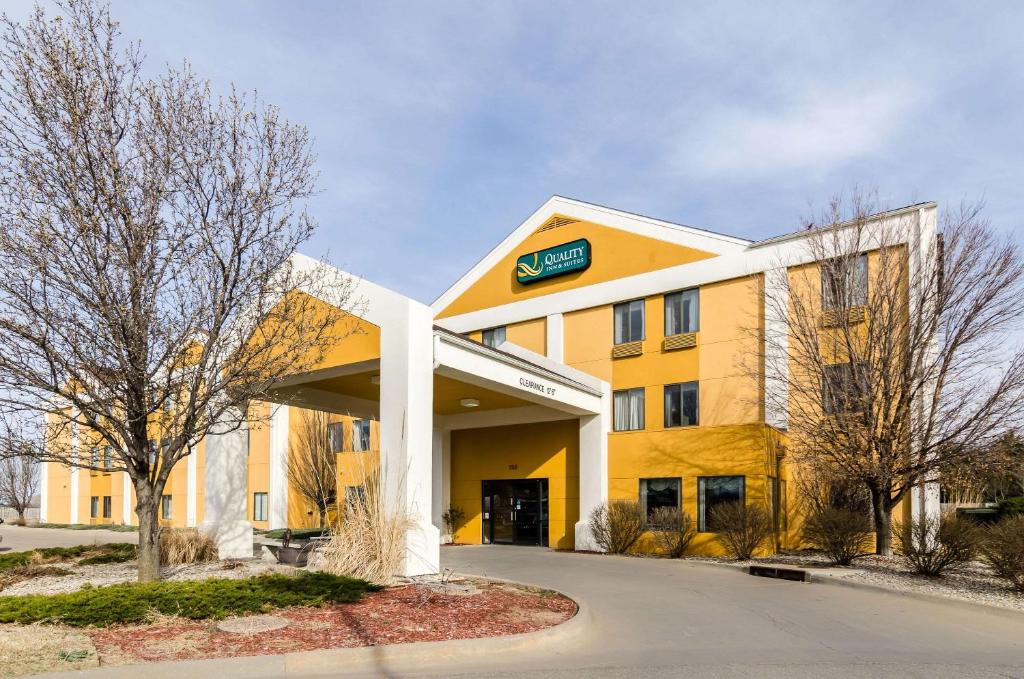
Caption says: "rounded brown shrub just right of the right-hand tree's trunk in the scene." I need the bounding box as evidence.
[896,512,981,578]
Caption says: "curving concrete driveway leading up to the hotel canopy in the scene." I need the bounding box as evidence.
[407,546,1024,679]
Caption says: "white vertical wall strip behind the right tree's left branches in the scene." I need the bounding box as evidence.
[764,266,790,429]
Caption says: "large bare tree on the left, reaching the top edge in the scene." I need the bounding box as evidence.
[0,0,351,581]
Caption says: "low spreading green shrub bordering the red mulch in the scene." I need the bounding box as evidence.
[0,572,379,627]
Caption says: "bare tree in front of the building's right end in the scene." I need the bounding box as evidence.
[764,197,1024,554]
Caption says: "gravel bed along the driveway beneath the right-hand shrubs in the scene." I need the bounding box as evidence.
[688,552,1024,611]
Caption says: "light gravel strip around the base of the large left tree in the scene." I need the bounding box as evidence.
[0,559,296,596]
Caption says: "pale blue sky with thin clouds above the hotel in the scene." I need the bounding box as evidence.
[4,0,1024,302]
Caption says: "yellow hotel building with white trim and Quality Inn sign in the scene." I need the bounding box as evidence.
[42,197,938,575]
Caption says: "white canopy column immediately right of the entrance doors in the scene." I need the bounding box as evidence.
[575,383,611,551]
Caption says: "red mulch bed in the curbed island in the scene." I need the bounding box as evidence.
[87,583,577,665]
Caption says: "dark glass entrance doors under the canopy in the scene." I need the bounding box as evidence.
[483,478,548,547]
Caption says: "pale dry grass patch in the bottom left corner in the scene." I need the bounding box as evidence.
[0,625,98,677]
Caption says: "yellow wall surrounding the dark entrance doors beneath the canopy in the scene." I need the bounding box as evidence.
[451,420,580,549]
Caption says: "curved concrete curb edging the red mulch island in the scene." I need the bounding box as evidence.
[37,576,594,679]
